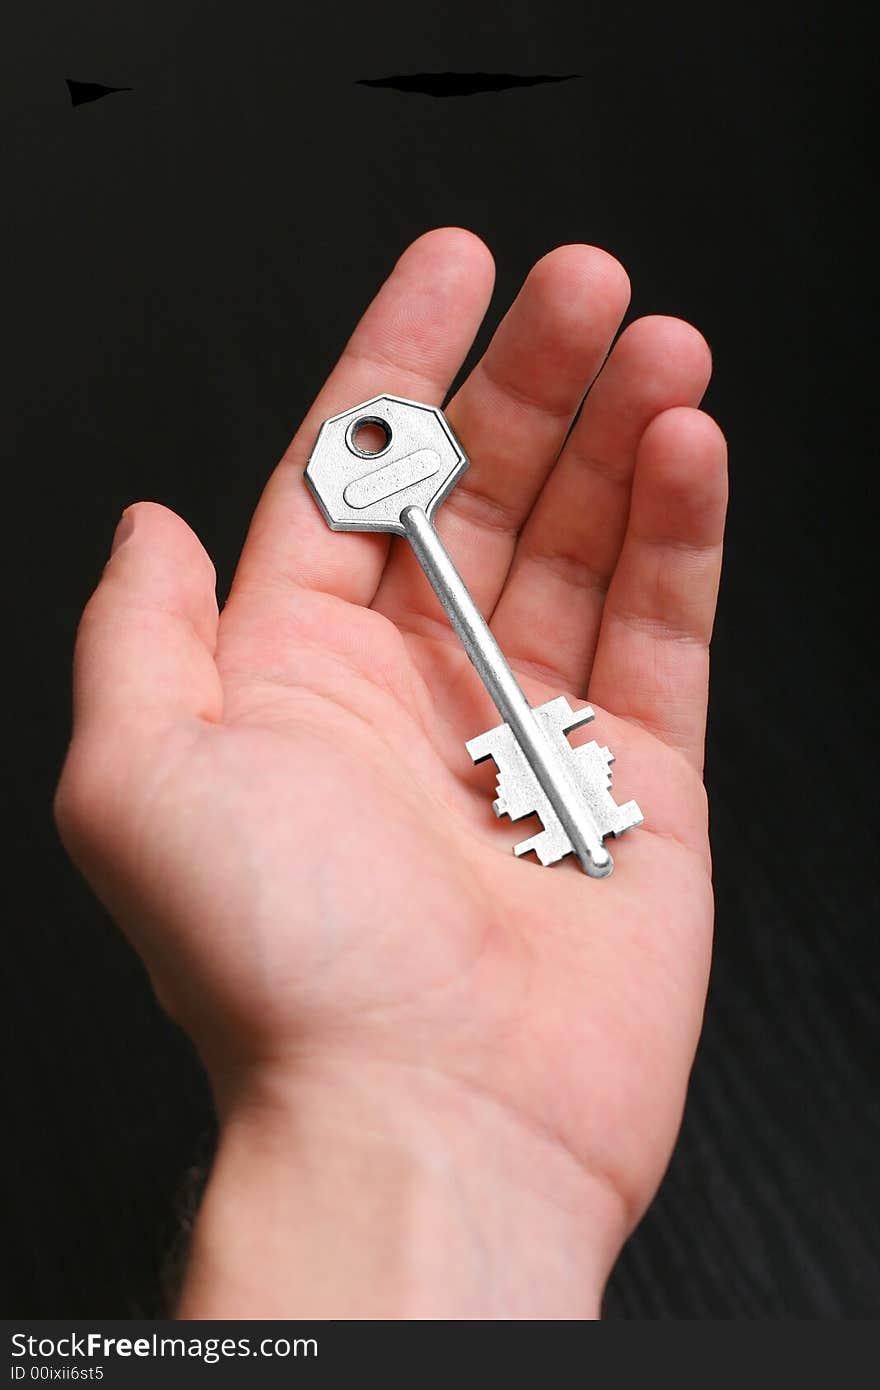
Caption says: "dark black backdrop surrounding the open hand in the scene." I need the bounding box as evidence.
[3,0,880,1318]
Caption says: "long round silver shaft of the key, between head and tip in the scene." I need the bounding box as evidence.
[400,506,613,878]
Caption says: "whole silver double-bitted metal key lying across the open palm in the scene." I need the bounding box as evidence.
[306,396,642,878]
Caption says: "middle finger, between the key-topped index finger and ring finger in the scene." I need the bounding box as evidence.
[373,246,630,632]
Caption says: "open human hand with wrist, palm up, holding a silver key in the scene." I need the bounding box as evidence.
[56,229,726,1318]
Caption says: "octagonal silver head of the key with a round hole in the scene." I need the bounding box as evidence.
[306,396,467,535]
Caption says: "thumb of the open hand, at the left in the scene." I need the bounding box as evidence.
[56,502,222,841]
